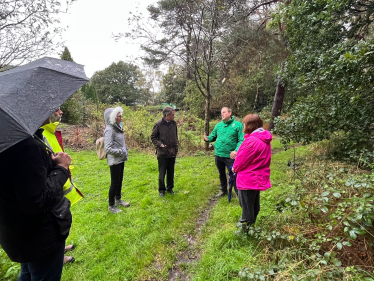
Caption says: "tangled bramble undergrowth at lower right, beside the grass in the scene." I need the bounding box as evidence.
[239,154,374,281]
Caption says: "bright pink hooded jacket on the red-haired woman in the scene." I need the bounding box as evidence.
[233,128,272,191]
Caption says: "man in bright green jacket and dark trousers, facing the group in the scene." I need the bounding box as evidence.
[204,107,244,197]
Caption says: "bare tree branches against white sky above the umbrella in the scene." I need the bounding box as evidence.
[0,0,75,69]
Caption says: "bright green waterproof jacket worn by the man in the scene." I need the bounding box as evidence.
[207,117,244,158]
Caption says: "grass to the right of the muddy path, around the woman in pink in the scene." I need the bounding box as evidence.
[190,143,310,281]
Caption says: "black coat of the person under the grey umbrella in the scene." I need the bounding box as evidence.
[0,130,72,262]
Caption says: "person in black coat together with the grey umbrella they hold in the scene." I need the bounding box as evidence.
[0,58,88,281]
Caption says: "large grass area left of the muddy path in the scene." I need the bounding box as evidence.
[63,148,218,280]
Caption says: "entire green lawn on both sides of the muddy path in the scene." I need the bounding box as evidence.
[0,140,308,281]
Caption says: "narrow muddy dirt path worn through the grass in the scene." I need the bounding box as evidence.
[169,197,217,281]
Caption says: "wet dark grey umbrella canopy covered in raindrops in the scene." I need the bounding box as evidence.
[0,57,88,152]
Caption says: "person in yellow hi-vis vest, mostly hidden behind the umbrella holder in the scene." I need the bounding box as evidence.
[41,108,84,264]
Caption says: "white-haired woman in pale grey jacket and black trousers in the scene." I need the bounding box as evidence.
[104,106,130,214]
